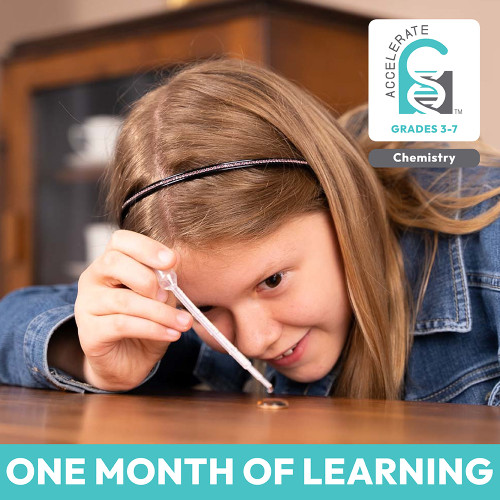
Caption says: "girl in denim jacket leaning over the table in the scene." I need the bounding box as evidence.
[0,60,500,405]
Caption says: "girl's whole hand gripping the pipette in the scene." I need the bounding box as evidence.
[75,230,193,391]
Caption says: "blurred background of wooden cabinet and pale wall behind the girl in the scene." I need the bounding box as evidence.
[0,0,500,296]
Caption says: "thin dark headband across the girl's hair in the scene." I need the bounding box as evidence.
[120,158,308,225]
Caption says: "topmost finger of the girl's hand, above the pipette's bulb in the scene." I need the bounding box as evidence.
[107,229,176,269]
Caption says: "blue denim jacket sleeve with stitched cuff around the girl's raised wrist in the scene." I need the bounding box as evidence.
[0,283,158,392]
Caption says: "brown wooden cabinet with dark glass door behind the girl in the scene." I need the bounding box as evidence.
[0,0,369,294]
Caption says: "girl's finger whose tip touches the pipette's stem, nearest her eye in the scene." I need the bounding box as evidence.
[90,288,193,332]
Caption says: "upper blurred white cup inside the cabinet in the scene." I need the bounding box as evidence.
[68,115,123,163]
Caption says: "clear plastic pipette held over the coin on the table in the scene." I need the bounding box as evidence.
[155,270,273,394]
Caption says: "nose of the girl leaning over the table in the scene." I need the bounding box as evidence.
[233,307,281,358]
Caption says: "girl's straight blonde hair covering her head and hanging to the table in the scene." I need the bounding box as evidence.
[108,59,500,399]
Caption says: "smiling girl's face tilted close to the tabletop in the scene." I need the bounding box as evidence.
[176,212,352,382]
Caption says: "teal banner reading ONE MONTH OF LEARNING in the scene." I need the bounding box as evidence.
[0,445,500,500]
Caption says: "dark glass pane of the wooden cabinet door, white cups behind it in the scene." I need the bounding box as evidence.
[33,73,164,285]
